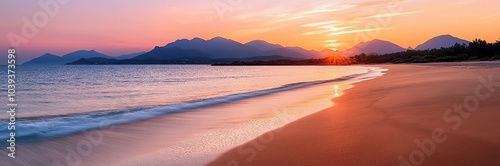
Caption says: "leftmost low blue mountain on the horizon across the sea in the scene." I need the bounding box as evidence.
[23,50,112,65]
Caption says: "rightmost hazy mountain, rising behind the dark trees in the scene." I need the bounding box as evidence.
[415,35,469,50]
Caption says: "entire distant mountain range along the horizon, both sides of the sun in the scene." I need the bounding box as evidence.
[24,35,468,65]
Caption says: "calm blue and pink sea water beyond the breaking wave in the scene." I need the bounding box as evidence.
[0,65,367,119]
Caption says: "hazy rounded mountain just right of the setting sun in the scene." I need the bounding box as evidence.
[343,39,406,56]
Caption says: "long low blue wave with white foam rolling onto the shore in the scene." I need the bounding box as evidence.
[0,69,382,142]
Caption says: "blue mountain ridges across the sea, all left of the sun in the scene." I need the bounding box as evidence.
[29,37,331,65]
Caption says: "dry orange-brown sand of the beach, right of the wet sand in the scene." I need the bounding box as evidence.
[208,62,500,166]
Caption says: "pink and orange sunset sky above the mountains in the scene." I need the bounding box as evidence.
[0,0,500,61]
